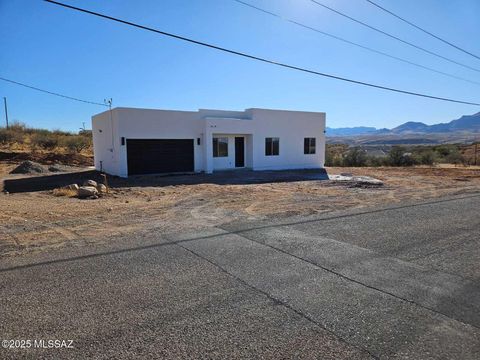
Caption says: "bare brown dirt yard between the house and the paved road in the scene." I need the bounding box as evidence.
[0,162,480,257]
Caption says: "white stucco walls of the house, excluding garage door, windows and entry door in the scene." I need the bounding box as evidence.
[92,108,325,177]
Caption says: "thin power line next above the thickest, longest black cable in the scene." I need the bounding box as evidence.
[233,0,480,85]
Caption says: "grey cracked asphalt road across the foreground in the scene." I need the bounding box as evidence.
[0,194,480,359]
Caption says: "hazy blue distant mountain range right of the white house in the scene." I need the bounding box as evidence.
[327,112,480,137]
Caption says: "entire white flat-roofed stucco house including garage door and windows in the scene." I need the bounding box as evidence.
[92,108,325,177]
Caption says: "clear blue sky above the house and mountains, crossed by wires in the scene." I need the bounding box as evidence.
[0,0,480,130]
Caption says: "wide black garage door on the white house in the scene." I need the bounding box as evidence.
[127,139,194,175]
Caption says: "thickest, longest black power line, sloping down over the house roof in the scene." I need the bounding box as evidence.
[44,0,480,106]
